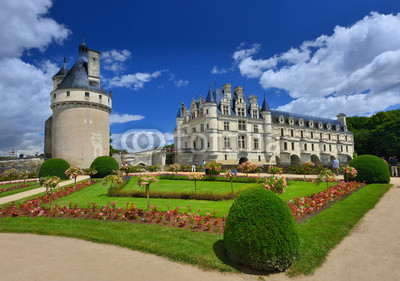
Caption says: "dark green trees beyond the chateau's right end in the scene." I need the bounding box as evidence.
[347,109,400,158]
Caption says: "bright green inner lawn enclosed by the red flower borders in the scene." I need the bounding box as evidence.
[51,180,336,217]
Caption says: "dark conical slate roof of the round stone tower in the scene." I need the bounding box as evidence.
[57,45,108,95]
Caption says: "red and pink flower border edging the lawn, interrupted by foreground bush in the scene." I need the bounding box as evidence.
[0,178,365,234]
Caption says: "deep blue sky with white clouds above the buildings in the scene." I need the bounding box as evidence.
[0,0,400,154]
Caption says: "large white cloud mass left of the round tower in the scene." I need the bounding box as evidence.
[0,0,70,155]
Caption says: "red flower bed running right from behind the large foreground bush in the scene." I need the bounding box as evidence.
[287,181,365,220]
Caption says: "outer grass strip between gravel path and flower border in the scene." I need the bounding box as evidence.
[0,184,390,275]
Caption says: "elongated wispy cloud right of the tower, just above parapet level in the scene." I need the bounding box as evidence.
[108,70,163,90]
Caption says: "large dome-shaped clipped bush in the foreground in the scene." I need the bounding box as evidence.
[224,188,300,271]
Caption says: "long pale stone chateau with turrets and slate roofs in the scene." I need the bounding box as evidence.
[174,84,354,165]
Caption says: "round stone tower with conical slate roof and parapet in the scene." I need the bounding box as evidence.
[44,42,112,168]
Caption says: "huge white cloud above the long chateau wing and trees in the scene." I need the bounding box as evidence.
[233,13,400,117]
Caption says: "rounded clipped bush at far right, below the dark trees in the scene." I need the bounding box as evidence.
[349,155,390,184]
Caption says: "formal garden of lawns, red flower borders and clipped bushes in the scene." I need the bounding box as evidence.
[0,156,390,275]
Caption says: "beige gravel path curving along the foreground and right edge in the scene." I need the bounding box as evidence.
[0,178,400,281]
